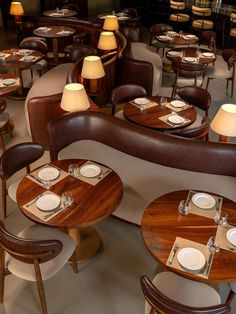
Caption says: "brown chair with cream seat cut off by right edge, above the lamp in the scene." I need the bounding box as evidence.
[205,49,236,97]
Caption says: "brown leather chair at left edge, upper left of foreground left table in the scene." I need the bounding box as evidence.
[0,142,44,217]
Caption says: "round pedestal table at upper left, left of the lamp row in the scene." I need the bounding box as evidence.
[33,25,75,65]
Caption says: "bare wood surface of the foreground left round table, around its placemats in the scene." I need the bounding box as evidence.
[17,159,123,228]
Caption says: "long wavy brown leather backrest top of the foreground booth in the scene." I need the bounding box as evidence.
[47,111,236,176]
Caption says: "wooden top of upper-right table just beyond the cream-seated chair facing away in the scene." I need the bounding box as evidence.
[166,47,217,64]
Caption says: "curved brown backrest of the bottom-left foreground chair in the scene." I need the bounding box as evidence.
[0,221,62,267]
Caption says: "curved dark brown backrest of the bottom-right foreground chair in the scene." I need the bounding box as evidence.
[140,276,230,314]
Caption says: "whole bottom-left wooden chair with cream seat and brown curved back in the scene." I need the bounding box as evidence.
[0,222,76,314]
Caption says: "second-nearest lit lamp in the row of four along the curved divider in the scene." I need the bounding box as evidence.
[81,56,105,94]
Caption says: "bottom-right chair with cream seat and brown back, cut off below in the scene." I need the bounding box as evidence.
[140,272,231,314]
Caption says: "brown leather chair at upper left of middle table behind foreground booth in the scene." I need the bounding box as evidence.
[111,84,147,115]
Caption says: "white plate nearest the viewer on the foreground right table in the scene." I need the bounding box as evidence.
[177,247,206,271]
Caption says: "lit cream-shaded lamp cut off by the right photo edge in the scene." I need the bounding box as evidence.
[211,104,236,142]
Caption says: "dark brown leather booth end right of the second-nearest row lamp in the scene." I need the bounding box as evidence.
[116,57,153,96]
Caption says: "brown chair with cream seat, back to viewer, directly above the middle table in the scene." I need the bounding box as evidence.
[171,61,206,98]
